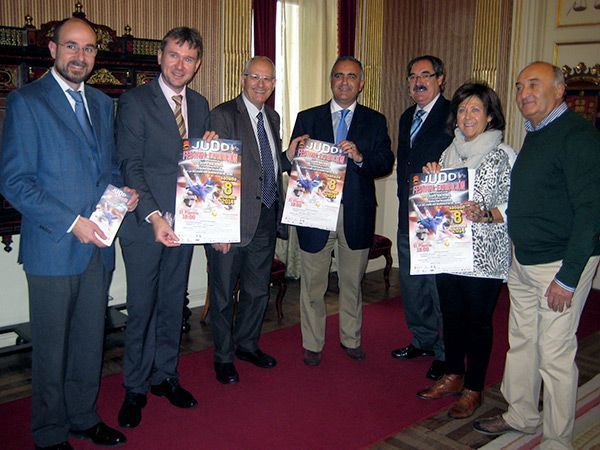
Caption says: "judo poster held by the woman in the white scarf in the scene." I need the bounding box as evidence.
[408,168,473,275]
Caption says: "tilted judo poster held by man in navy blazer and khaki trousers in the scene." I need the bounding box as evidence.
[281,139,348,231]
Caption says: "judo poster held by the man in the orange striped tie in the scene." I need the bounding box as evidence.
[174,138,242,244]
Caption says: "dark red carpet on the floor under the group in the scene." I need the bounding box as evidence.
[0,290,600,450]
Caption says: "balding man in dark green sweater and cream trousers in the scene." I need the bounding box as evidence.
[474,62,600,449]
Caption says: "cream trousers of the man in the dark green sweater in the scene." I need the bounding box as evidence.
[501,256,599,449]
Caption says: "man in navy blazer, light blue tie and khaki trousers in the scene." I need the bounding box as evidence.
[288,56,394,366]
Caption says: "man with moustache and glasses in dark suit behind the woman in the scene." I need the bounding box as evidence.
[392,55,452,380]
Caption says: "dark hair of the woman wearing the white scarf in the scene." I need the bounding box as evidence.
[448,81,506,132]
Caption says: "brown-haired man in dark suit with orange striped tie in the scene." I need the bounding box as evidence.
[116,27,209,428]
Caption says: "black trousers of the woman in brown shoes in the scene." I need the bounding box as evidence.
[436,274,502,391]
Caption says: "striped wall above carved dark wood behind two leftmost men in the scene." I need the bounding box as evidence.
[0,0,222,107]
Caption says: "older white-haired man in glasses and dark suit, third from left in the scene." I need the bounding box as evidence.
[206,56,302,384]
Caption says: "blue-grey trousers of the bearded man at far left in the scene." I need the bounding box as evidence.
[27,249,108,447]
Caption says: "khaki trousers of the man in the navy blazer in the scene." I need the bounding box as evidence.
[300,208,369,352]
